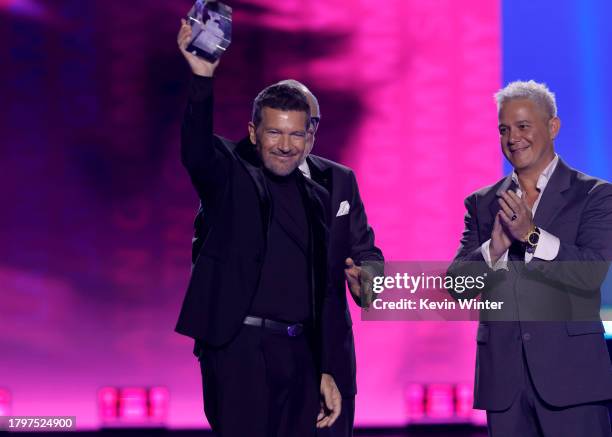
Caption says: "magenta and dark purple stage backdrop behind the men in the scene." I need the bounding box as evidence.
[0,0,501,428]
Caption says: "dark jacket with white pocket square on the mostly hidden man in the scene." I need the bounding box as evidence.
[307,155,384,397]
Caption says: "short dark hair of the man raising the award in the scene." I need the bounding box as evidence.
[251,84,310,127]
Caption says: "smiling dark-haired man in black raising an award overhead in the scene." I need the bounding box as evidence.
[176,20,341,437]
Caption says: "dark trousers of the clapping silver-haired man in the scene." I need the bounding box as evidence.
[487,346,612,437]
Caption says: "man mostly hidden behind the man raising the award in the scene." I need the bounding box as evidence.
[278,80,384,437]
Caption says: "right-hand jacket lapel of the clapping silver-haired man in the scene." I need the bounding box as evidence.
[533,159,572,229]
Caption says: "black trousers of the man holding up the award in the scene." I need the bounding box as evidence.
[200,325,320,437]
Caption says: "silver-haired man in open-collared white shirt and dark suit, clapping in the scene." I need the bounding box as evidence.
[449,81,612,437]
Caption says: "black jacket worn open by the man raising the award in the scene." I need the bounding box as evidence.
[176,76,329,367]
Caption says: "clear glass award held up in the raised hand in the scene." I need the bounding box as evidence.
[187,0,232,62]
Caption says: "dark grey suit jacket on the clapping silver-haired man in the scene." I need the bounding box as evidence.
[449,160,612,410]
